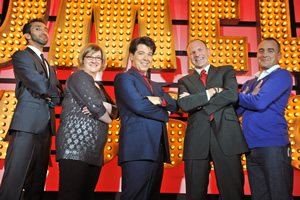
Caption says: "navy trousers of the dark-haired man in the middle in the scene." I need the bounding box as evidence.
[121,144,164,200]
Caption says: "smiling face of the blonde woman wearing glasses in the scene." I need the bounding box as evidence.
[83,51,102,78]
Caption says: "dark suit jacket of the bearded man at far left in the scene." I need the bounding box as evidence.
[10,47,62,135]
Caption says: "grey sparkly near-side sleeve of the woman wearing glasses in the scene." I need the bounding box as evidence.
[66,71,106,119]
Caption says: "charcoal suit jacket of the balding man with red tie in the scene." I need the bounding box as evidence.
[178,65,248,160]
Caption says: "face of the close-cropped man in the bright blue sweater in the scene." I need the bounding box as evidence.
[257,40,282,70]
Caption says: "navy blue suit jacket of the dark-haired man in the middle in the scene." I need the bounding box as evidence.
[114,69,177,164]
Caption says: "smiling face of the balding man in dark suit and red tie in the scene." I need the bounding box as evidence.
[187,40,210,69]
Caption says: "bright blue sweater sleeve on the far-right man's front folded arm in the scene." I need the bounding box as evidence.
[239,70,292,110]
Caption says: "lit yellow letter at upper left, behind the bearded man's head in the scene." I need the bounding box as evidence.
[0,0,51,67]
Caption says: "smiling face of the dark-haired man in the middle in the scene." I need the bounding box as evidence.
[129,44,153,75]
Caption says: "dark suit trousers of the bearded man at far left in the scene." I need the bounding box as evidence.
[0,130,52,200]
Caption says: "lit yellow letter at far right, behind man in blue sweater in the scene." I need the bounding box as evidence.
[256,0,300,72]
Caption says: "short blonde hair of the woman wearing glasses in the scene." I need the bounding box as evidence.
[78,43,106,72]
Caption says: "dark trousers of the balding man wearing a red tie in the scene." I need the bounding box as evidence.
[185,120,244,200]
